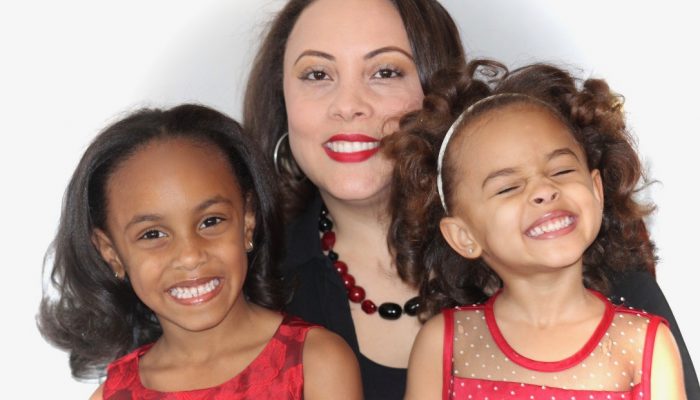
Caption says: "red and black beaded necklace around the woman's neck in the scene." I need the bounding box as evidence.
[318,206,420,320]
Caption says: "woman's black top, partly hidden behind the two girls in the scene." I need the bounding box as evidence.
[283,196,700,400]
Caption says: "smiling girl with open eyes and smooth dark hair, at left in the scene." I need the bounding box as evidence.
[39,105,361,399]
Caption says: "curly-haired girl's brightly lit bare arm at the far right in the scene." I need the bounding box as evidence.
[651,324,686,400]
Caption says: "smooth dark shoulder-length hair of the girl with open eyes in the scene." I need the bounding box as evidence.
[37,104,286,379]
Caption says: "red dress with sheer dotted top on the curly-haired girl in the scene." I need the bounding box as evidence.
[443,292,666,400]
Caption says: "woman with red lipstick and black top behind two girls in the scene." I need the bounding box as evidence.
[244,0,697,399]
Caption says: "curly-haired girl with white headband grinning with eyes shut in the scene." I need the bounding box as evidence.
[387,62,685,400]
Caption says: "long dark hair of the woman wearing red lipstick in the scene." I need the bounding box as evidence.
[243,0,464,217]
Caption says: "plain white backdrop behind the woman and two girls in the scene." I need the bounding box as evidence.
[0,0,700,399]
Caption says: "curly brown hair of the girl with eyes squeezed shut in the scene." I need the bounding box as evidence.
[383,60,656,318]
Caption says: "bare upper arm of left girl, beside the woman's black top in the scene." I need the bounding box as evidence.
[303,328,362,400]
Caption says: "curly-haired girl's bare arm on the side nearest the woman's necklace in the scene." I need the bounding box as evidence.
[404,314,442,400]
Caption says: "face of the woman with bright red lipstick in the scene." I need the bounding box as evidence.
[284,0,423,203]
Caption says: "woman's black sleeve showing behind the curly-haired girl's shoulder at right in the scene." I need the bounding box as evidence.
[611,270,700,399]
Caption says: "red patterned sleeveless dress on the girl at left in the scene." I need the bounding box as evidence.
[103,316,313,400]
